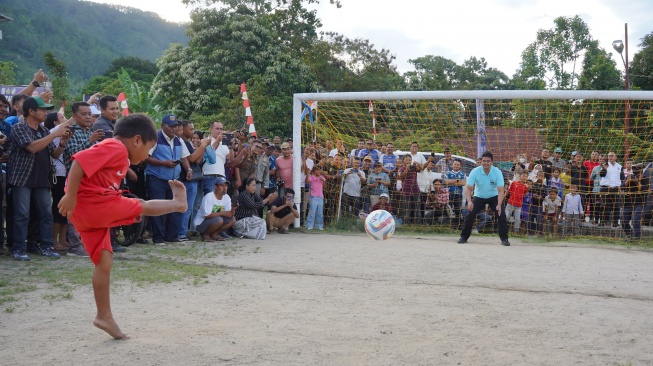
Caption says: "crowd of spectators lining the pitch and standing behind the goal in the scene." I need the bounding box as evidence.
[0,71,650,260]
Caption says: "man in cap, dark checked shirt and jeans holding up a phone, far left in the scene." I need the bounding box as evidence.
[7,97,71,261]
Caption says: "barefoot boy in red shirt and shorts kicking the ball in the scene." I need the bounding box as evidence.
[58,114,187,339]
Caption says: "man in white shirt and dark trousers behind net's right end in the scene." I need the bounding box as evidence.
[599,151,626,229]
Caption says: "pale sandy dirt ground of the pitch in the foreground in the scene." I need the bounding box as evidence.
[0,233,653,365]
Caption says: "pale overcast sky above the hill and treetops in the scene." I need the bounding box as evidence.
[86,0,653,76]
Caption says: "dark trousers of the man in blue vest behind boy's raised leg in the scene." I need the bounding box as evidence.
[147,176,182,243]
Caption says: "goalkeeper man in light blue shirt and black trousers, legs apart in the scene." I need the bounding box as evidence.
[458,151,510,246]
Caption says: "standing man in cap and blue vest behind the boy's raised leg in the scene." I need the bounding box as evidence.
[145,114,193,244]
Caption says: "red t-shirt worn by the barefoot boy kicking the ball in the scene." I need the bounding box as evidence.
[72,139,129,203]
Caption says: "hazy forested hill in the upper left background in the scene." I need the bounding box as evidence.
[0,0,188,88]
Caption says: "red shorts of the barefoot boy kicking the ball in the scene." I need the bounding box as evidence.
[70,196,143,266]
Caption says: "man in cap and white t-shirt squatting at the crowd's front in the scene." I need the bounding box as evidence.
[195,177,238,241]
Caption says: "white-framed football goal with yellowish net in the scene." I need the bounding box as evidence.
[293,91,653,242]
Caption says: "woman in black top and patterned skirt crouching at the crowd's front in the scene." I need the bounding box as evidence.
[233,178,278,240]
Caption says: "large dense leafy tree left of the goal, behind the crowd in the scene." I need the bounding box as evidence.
[154,6,315,135]
